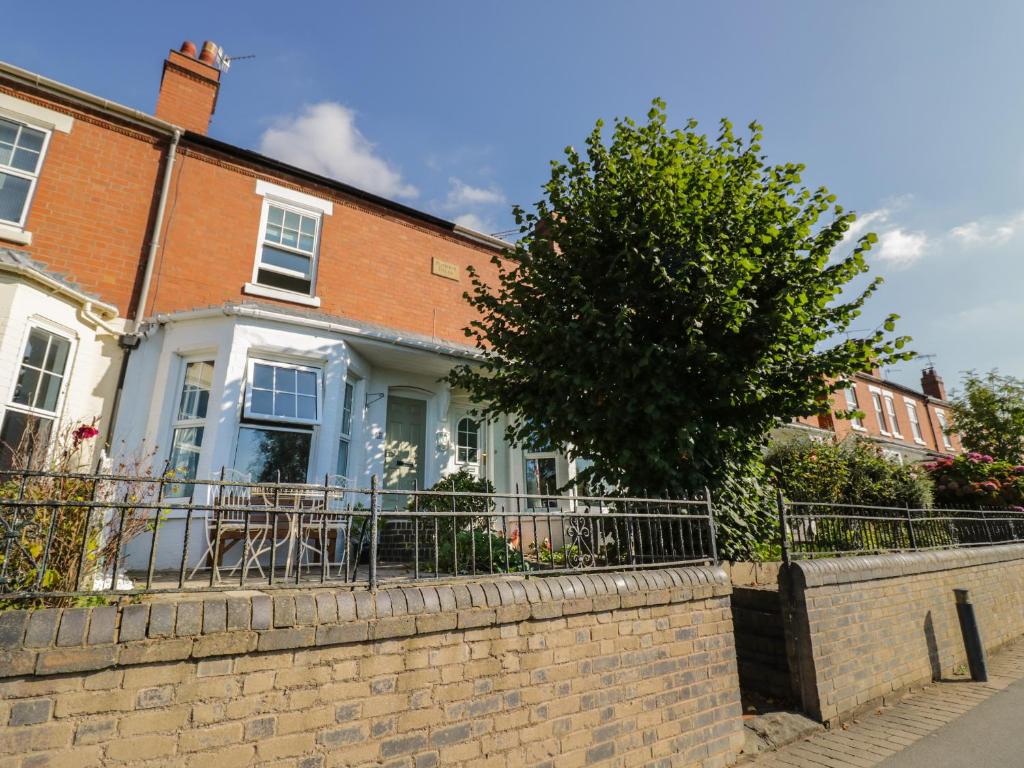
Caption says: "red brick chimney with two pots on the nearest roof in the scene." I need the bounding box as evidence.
[157,40,220,134]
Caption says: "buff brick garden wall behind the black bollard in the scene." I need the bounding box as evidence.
[780,545,1024,722]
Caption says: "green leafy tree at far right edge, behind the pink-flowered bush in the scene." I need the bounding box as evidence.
[952,371,1024,464]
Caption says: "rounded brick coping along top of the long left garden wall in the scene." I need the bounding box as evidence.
[0,565,729,678]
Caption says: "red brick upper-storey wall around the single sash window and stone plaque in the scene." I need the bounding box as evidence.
[146,147,505,342]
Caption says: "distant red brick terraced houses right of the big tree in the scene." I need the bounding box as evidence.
[779,367,963,462]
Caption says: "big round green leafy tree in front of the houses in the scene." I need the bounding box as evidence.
[450,100,906,554]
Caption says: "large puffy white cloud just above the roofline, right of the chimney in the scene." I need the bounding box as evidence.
[259,101,419,198]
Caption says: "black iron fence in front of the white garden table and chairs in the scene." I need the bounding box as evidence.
[0,472,718,605]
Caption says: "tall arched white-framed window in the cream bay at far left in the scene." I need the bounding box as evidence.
[0,327,72,469]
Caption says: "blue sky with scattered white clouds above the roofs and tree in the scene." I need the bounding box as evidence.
[8,0,1024,391]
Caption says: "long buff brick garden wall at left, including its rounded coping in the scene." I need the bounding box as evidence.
[0,568,742,768]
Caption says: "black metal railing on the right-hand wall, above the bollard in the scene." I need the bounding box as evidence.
[777,495,1024,561]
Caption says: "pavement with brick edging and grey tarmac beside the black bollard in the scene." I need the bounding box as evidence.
[742,641,1024,768]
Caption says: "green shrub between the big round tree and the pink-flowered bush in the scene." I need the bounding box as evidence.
[765,438,934,509]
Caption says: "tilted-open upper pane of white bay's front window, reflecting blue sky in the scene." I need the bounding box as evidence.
[243,358,323,424]
